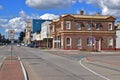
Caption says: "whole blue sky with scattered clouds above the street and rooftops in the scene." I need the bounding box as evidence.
[0,0,120,38]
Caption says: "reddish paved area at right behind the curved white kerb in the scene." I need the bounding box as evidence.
[84,55,120,71]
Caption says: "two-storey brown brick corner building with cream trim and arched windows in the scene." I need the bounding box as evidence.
[50,11,116,51]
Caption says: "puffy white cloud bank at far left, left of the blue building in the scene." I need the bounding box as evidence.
[0,11,27,33]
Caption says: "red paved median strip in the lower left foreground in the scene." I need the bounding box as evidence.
[0,56,24,80]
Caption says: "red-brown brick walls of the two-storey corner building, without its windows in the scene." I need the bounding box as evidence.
[50,14,115,50]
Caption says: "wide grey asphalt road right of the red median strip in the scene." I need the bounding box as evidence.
[0,46,120,80]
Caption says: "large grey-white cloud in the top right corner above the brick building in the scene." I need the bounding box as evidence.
[79,0,120,17]
